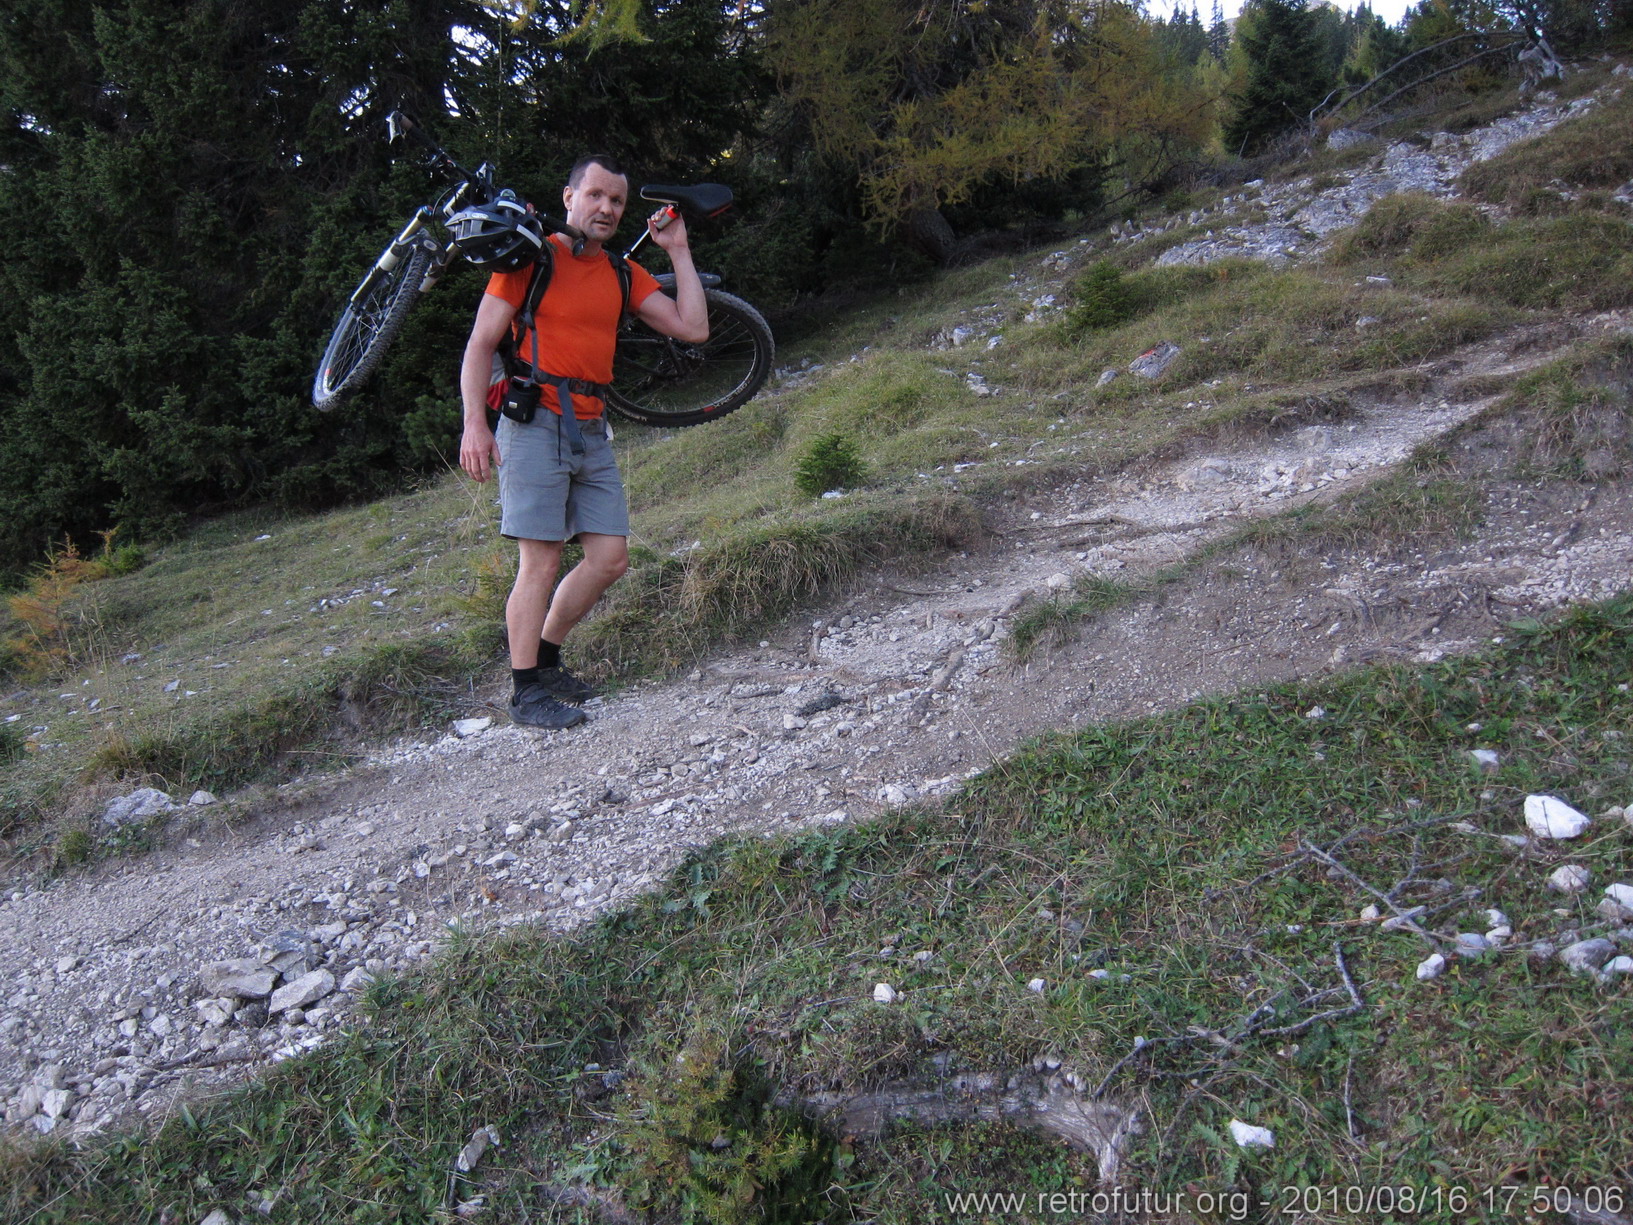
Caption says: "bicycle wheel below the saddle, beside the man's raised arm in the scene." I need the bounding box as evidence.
[607,289,776,428]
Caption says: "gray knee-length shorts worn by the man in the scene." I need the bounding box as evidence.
[498,413,629,541]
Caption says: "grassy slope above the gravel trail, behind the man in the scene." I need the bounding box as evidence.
[0,76,1633,851]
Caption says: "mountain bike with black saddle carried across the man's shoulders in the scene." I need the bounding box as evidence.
[312,111,776,426]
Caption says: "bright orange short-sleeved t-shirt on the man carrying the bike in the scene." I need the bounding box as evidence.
[487,234,658,421]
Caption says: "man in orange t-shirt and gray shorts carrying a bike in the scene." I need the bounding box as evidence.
[459,155,709,728]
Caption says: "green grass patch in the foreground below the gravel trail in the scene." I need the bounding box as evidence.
[0,598,1633,1225]
